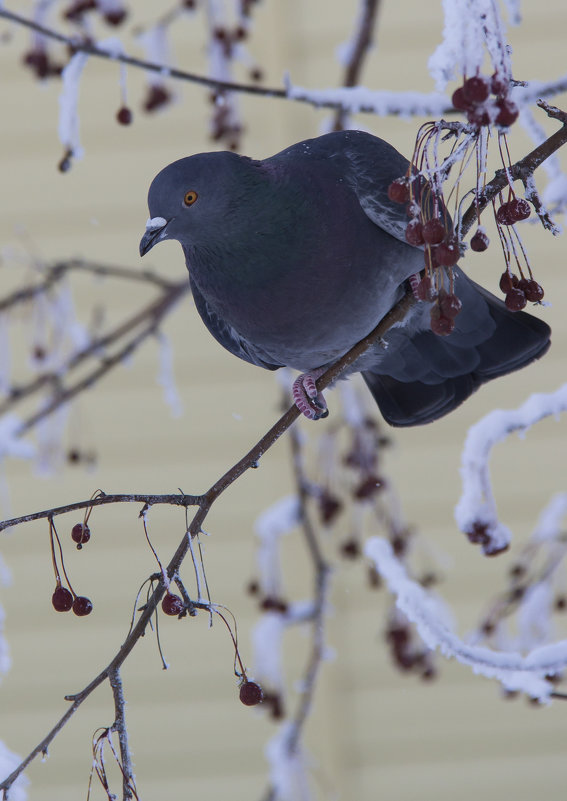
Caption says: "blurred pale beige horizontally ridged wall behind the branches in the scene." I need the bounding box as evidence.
[0,0,567,801]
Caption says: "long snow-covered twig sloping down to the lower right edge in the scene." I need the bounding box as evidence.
[365,537,567,702]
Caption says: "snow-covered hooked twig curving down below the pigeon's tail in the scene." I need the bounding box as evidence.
[455,384,567,556]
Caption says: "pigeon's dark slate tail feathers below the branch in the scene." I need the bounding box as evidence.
[362,286,551,426]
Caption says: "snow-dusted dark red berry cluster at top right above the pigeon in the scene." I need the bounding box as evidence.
[451,73,519,128]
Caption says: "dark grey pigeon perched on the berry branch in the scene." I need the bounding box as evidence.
[140,130,551,426]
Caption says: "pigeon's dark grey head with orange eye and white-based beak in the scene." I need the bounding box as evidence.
[140,151,258,256]
